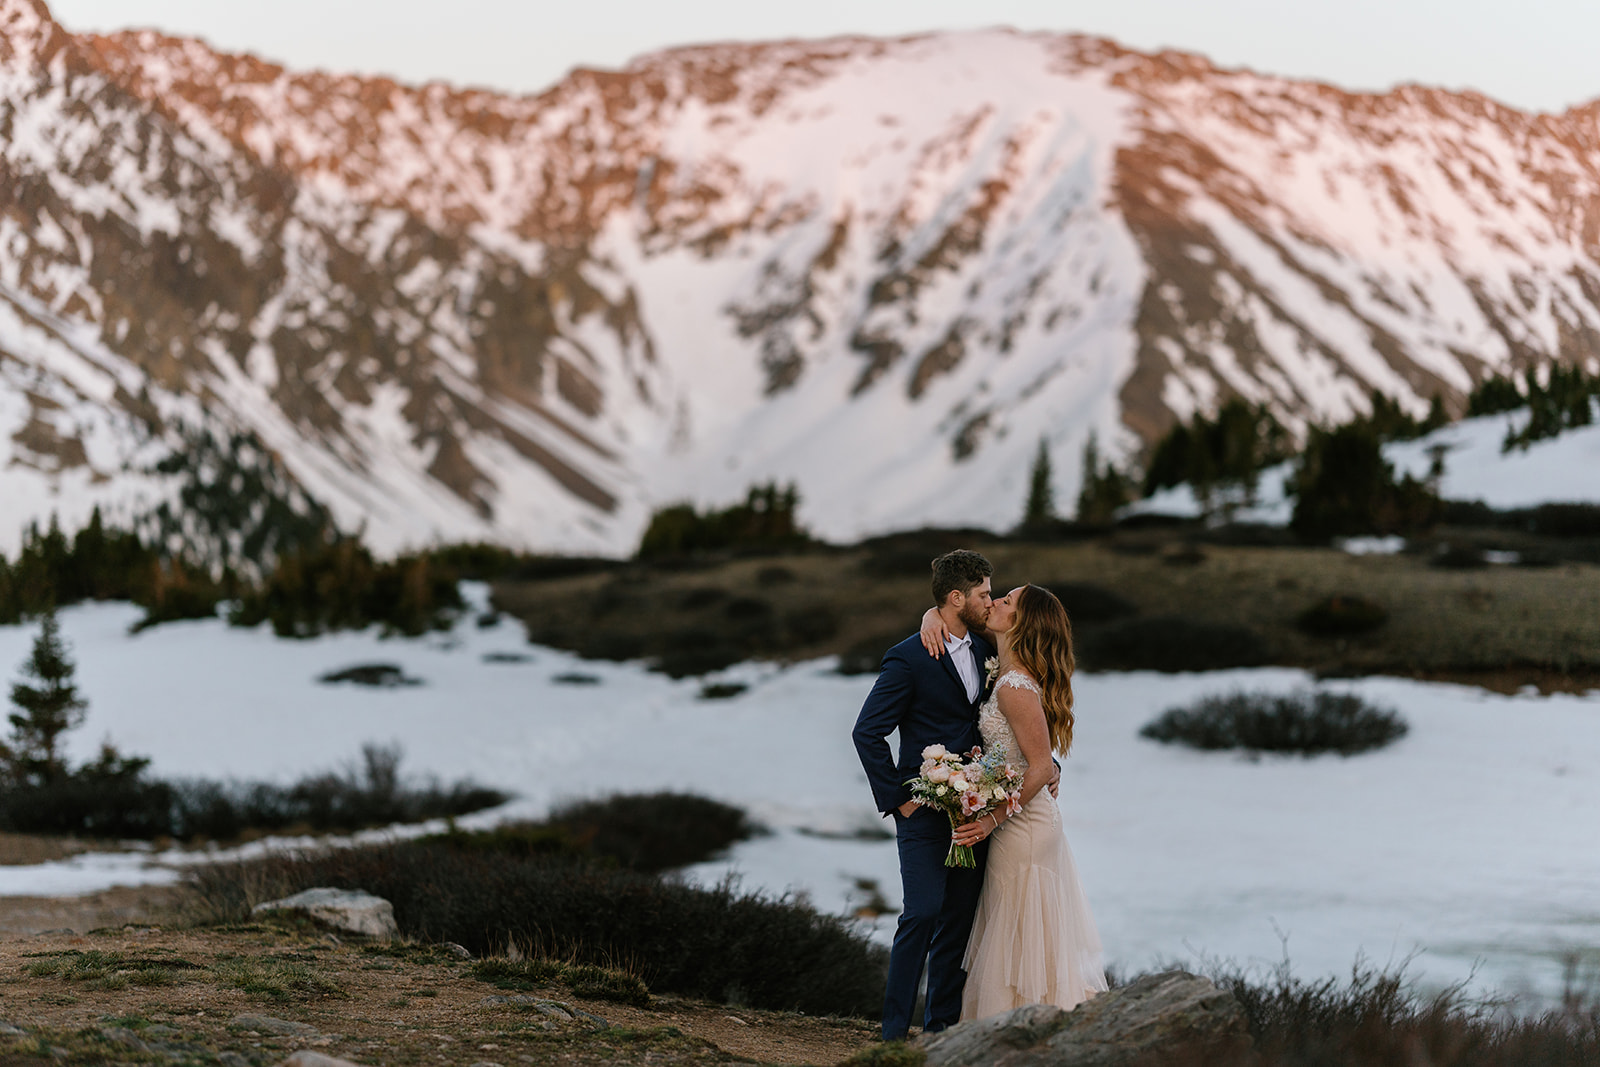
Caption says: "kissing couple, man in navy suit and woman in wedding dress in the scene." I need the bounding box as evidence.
[853,550,1106,1041]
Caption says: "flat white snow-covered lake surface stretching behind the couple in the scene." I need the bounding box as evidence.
[0,587,1600,1000]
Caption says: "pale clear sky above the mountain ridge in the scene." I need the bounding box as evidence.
[48,0,1600,110]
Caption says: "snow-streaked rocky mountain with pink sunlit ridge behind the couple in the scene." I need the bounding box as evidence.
[0,0,1600,552]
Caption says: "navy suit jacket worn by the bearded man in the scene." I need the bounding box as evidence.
[853,633,995,814]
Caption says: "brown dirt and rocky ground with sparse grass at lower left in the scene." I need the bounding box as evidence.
[0,891,874,1067]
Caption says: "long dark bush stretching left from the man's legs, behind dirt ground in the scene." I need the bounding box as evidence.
[189,843,888,1017]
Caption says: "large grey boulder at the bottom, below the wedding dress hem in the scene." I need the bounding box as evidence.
[917,971,1250,1067]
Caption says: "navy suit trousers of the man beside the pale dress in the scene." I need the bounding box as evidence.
[883,808,989,1041]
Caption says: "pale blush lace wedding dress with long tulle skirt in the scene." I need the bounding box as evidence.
[962,670,1106,1019]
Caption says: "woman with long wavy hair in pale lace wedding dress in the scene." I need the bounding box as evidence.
[922,585,1106,1021]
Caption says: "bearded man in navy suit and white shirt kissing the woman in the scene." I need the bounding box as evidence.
[854,549,995,1041]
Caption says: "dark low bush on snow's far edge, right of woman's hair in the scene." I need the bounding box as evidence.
[1078,616,1269,670]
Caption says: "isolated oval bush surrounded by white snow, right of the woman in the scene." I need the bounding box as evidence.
[1139,691,1406,757]
